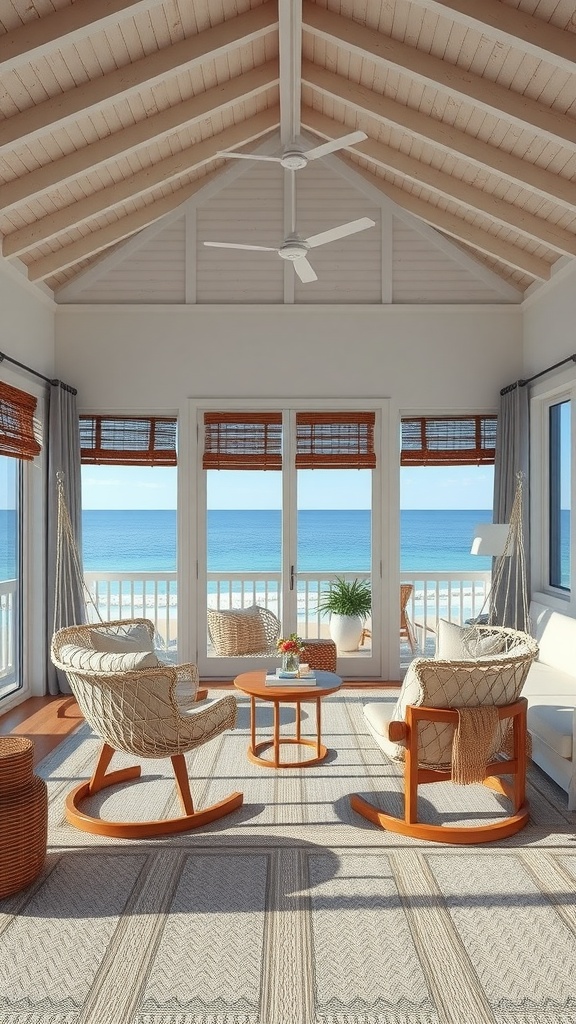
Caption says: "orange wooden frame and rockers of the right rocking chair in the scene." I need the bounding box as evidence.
[351,697,530,845]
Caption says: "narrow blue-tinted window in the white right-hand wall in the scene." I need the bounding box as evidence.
[548,400,571,590]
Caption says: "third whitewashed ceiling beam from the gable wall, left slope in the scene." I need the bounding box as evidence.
[0,60,278,211]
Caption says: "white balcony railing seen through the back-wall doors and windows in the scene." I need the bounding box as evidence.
[85,571,490,647]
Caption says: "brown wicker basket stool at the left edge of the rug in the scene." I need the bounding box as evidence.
[0,736,48,898]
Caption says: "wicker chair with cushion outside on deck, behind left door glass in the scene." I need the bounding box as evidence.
[207,604,281,657]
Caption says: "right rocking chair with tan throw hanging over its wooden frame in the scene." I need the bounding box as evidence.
[351,627,538,844]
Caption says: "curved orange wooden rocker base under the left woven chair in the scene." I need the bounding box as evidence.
[66,743,244,839]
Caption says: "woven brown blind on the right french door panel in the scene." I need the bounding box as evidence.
[296,413,376,469]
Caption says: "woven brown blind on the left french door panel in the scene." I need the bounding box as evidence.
[202,413,282,469]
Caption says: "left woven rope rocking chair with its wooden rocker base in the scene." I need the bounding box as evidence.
[51,620,243,839]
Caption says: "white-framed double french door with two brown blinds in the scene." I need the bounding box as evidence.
[193,399,387,679]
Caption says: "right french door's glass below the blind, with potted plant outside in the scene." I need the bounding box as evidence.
[296,469,375,675]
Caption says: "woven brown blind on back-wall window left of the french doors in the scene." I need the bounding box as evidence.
[80,416,176,466]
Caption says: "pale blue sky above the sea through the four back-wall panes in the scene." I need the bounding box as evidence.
[82,466,494,509]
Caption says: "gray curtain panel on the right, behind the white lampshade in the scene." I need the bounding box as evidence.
[491,385,530,632]
